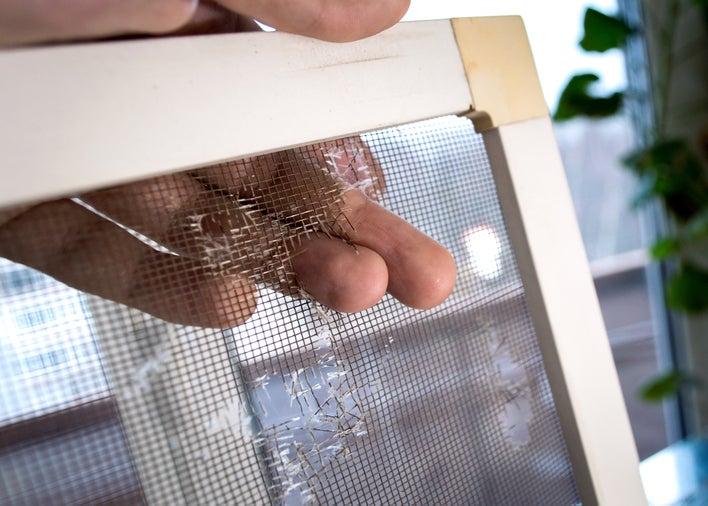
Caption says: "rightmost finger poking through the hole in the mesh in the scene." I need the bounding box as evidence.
[224,150,456,309]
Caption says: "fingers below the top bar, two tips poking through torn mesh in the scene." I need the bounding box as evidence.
[0,139,455,328]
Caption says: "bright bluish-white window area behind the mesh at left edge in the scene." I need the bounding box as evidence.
[0,259,108,425]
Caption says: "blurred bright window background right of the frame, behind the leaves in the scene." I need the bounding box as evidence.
[406,0,708,486]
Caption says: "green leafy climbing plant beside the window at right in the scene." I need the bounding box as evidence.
[554,0,708,402]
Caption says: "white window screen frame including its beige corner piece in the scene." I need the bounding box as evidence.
[0,17,646,506]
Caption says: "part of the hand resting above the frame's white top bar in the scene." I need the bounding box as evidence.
[0,0,409,47]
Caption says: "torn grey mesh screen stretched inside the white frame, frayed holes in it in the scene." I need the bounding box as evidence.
[0,117,578,505]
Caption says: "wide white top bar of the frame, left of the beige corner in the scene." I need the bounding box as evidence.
[0,21,471,206]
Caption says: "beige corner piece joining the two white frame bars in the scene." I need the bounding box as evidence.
[451,16,549,132]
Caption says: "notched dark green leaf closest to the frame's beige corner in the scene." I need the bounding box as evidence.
[553,73,623,121]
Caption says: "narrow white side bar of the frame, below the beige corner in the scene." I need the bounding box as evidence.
[484,118,646,506]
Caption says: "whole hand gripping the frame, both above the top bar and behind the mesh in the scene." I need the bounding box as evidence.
[0,0,455,327]
